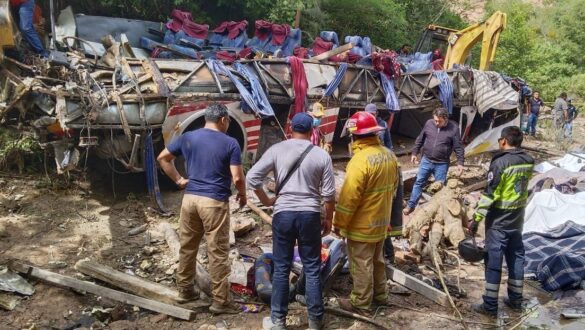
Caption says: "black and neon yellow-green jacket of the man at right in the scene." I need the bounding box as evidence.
[474,149,534,230]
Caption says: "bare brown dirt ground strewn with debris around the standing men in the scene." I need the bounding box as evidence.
[0,119,585,329]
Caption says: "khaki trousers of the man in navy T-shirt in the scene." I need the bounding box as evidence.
[177,194,230,305]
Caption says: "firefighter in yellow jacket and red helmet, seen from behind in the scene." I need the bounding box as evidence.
[333,111,399,315]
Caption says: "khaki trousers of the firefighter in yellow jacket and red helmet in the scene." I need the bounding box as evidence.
[347,239,388,309]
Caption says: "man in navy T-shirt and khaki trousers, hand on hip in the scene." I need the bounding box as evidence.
[158,104,246,314]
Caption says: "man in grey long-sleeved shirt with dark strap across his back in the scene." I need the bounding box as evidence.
[246,113,335,329]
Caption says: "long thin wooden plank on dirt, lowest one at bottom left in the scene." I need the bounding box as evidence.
[10,261,196,321]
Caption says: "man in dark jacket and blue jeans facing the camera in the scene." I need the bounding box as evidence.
[403,108,465,215]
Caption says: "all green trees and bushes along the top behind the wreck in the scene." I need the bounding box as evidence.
[69,0,585,101]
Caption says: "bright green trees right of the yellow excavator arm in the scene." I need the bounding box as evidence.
[486,0,585,101]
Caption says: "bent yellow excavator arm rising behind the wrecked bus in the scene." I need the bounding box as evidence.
[445,11,507,70]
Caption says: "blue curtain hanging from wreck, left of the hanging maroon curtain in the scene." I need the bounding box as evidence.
[205,60,274,117]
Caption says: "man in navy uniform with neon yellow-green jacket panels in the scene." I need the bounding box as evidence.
[469,126,534,316]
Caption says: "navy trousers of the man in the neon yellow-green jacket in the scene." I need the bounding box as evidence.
[483,228,524,311]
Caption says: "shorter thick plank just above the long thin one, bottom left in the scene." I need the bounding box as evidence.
[75,260,179,304]
